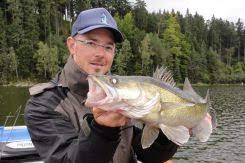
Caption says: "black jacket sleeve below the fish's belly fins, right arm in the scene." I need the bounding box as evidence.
[132,127,178,163]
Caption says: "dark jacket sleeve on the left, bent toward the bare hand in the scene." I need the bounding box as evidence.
[25,90,120,163]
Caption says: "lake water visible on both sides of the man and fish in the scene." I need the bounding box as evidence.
[0,86,245,163]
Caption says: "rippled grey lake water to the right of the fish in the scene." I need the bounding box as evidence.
[174,86,245,163]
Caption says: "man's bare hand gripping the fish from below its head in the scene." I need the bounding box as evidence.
[92,108,128,127]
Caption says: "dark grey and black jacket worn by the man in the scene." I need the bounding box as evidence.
[25,57,178,163]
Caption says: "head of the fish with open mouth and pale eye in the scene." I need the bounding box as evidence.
[85,75,144,109]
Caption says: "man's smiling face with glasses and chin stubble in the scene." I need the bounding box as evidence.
[67,28,115,74]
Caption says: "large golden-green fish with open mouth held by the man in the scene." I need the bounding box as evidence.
[85,67,217,149]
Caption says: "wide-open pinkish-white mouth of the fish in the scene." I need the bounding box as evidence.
[85,75,115,107]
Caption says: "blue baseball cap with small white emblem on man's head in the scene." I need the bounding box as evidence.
[71,8,123,42]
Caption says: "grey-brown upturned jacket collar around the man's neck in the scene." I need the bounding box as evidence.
[58,55,88,97]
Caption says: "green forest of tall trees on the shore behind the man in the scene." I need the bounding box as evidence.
[0,0,245,84]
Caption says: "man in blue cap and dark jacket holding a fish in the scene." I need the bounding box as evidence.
[25,8,177,163]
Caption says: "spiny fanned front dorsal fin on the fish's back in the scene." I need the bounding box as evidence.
[153,66,176,87]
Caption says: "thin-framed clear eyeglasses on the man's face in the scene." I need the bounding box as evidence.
[76,40,115,54]
